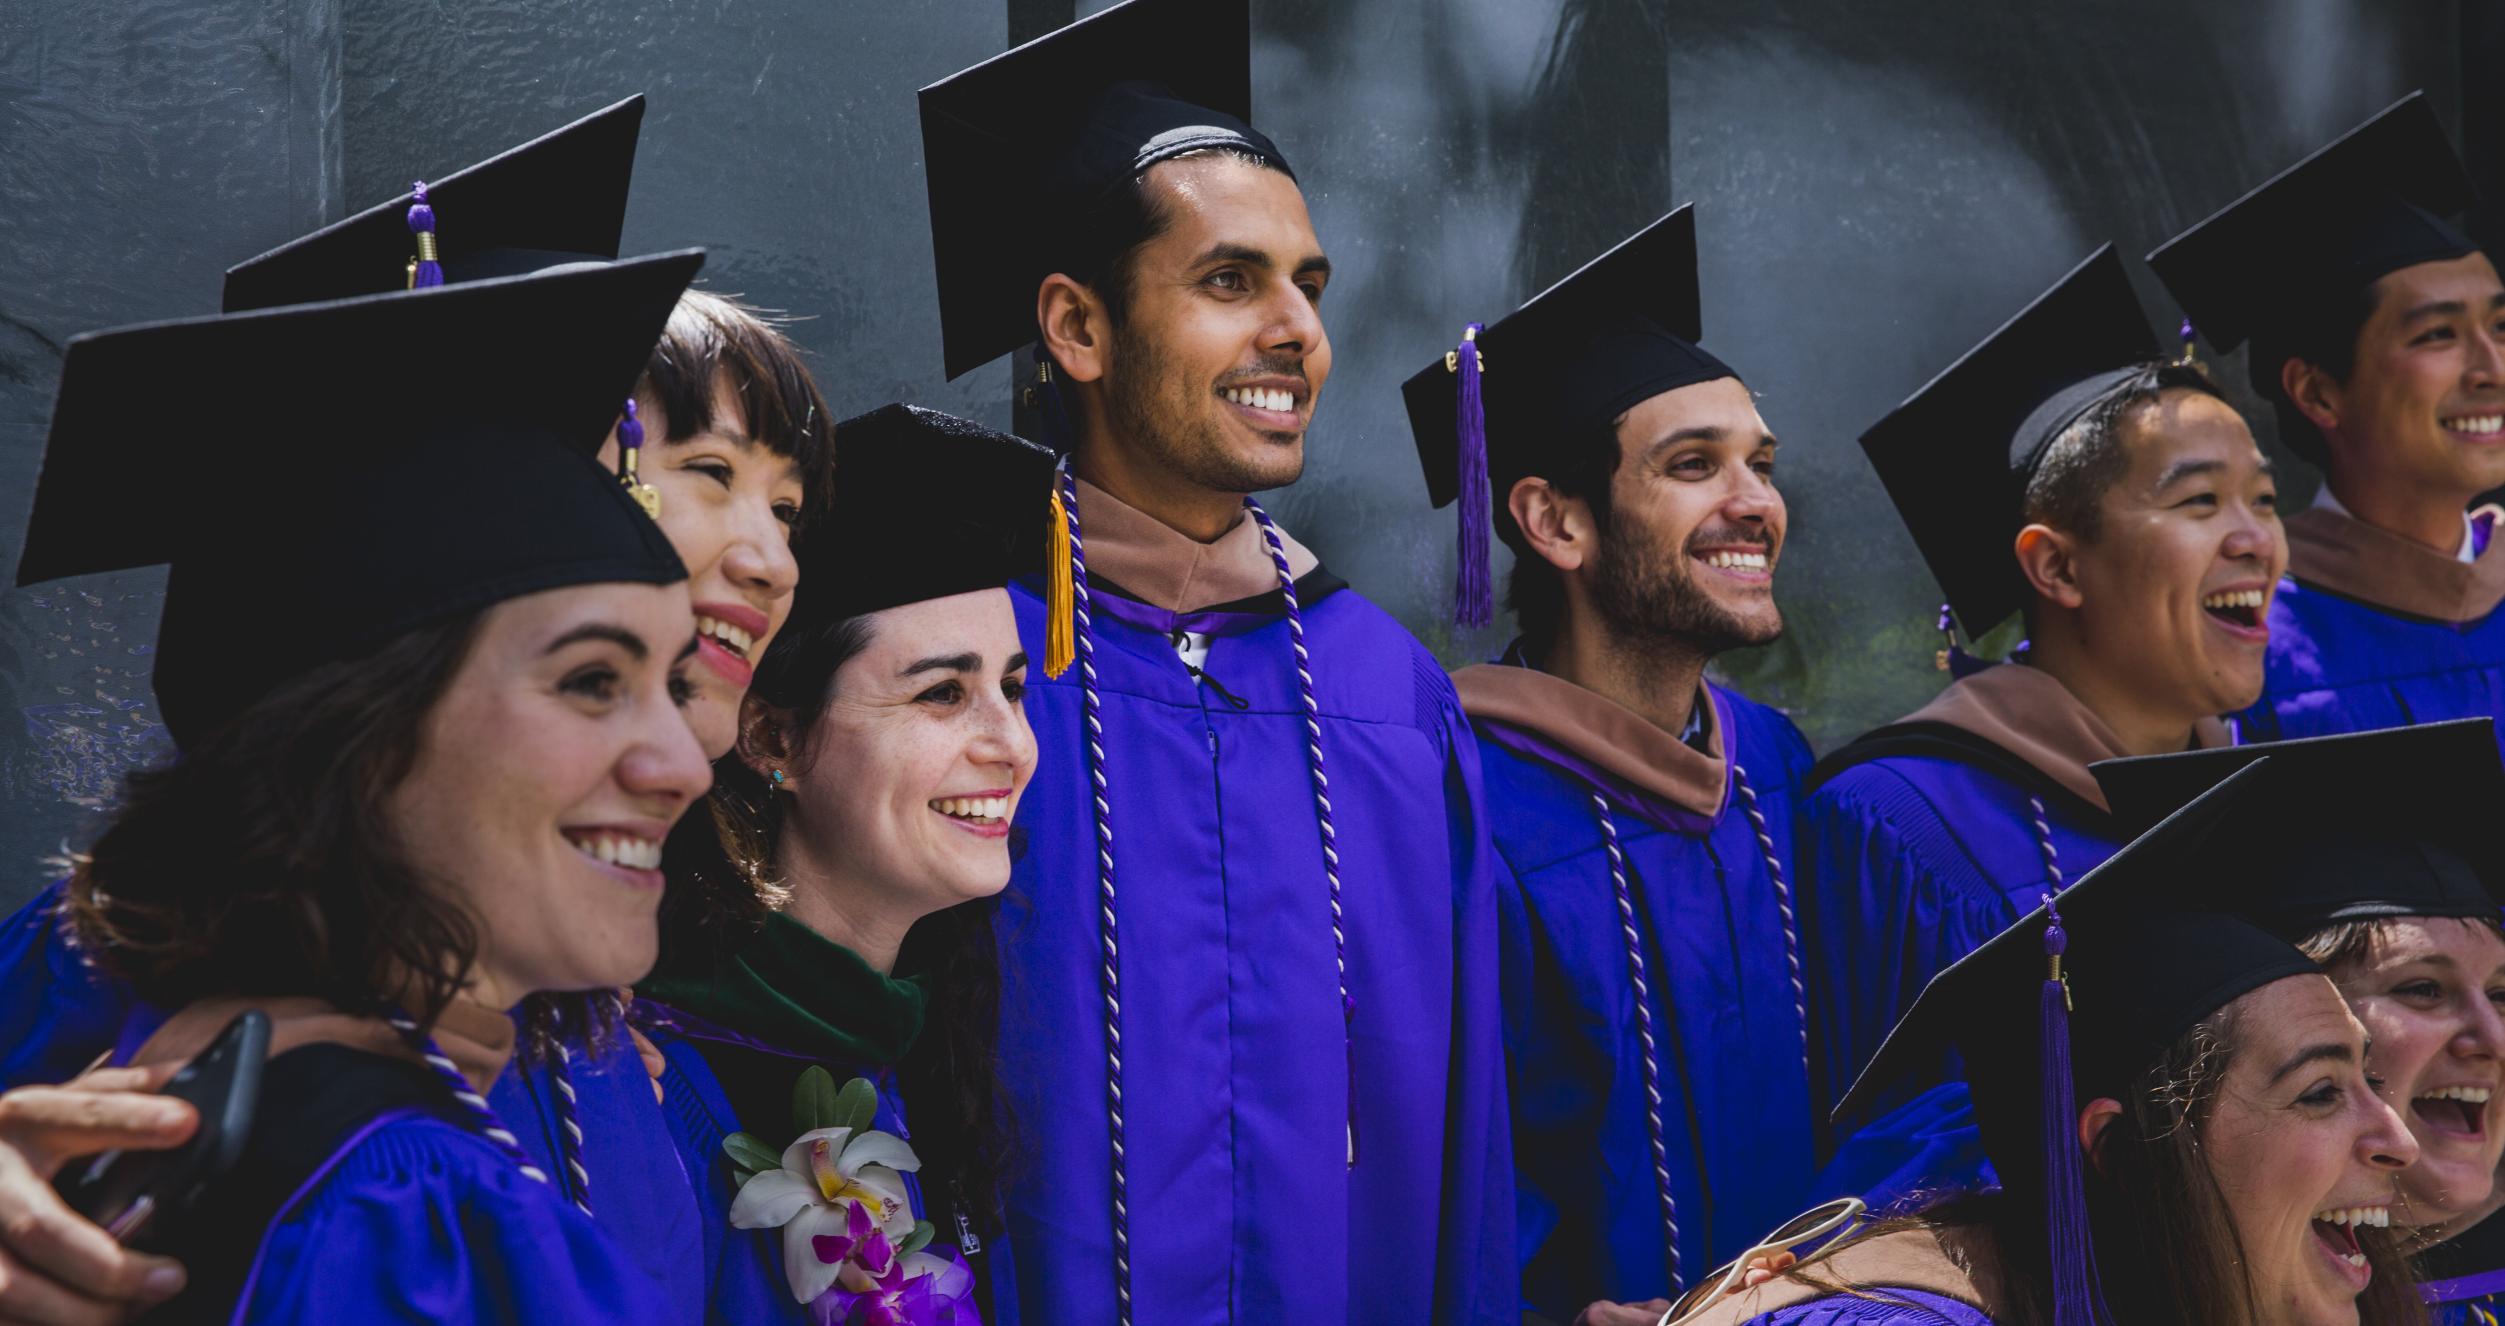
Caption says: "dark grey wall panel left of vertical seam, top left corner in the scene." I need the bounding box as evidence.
[0,0,343,907]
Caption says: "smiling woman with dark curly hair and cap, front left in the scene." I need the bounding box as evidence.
[18,253,709,1321]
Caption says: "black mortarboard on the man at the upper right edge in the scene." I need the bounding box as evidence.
[2149,93,2477,358]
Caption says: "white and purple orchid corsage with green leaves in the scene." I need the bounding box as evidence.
[721,1068,974,1323]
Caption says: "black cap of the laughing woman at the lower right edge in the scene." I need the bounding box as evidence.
[2092,719,2505,940]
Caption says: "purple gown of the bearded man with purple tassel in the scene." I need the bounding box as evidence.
[1473,669,1814,1321]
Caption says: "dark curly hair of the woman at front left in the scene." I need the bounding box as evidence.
[68,609,616,1050]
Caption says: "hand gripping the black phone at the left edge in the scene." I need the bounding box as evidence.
[0,1063,200,1326]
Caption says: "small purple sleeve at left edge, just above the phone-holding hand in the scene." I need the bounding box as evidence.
[0,882,135,1090]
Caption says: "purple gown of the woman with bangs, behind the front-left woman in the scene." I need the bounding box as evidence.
[0,882,704,1321]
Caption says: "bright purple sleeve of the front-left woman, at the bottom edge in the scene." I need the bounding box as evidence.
[235,1118,674,1326]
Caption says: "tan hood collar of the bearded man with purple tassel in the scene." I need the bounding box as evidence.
[1453,642,1731,820]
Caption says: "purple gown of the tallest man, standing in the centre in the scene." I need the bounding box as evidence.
[997,572,1518,1326]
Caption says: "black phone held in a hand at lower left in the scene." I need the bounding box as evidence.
[58,1008,271,1243]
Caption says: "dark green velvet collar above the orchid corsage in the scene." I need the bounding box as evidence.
[636,912,931,1065]
